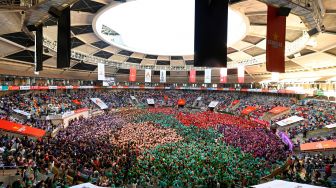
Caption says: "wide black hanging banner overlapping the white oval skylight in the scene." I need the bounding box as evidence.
[194,0,229,67]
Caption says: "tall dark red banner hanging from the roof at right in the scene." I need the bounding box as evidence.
[266,5,286,73]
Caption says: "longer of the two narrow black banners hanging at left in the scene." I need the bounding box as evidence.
[48,6,71,68]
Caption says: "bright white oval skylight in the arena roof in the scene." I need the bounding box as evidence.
[93,0,250,56]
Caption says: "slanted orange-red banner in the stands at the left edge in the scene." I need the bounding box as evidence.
[0,120,46,138]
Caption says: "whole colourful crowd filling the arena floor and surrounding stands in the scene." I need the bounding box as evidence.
[0,90,336,187]
